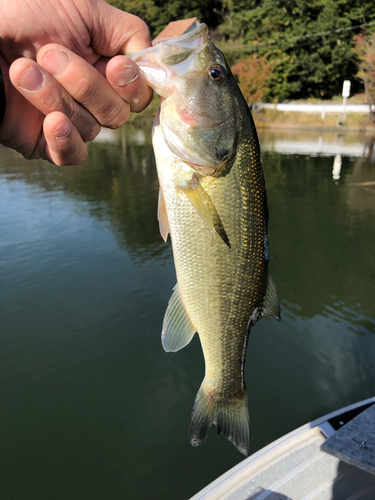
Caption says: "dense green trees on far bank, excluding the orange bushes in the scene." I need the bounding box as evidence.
[220,0,375,101]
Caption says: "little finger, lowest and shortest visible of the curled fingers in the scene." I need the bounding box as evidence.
[43,111,87,166]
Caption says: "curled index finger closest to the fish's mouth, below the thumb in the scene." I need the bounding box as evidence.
[106,56,152,113]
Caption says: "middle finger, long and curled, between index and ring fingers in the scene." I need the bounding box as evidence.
[37,44,132,128]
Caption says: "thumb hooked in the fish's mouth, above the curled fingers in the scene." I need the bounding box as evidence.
[89,0,151,57]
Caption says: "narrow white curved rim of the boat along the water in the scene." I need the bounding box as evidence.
[190,397,375,500]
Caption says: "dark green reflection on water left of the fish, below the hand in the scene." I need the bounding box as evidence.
[1,126,170,260]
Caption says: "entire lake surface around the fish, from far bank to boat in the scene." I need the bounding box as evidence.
[0,126,375,500]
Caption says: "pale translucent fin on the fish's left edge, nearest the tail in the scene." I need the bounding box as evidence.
[161,285,197,352]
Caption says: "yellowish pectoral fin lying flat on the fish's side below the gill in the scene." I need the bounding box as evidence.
[180,175,230,248]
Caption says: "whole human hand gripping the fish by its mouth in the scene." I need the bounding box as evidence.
[0,0,152,165]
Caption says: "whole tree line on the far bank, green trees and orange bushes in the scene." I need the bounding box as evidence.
[107,0,375,108]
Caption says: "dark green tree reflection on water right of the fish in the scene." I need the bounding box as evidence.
[263,139,375,332]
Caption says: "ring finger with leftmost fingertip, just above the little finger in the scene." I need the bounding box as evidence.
[9,58,100,142]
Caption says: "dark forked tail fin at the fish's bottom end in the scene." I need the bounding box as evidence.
[189,381,251,457]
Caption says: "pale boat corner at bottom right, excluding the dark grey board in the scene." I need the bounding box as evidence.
[191,399,375,500]
